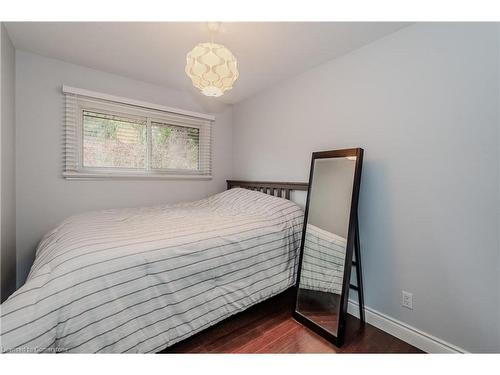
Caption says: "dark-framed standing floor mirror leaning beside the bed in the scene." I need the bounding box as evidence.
[293,148,364,346]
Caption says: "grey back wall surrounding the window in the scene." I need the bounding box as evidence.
[16,51,232,284]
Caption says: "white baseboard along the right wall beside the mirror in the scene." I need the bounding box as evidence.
[347,300,467,353]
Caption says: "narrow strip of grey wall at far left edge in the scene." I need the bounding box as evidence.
[0,23,16,301]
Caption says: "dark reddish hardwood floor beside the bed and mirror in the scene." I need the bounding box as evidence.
[162,293,422,353]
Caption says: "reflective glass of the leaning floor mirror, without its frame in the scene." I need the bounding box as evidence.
[296,156,356,335]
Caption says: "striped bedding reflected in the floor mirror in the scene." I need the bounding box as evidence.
[299,224,346,294]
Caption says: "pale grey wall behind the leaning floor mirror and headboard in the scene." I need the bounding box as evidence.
[233,23,500,352]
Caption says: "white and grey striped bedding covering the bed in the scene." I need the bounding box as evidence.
[1,189,303,353]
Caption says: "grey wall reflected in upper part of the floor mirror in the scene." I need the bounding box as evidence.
[308,158,356,238]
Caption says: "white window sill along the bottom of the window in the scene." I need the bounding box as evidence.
[63,172,212,181]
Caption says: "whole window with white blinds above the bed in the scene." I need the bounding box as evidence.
[63,86,213,179]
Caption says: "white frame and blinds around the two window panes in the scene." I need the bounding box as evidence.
[63,86,215,180]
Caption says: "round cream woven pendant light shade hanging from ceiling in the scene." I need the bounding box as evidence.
[186,43,239,96]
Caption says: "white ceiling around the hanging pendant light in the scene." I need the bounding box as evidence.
[6,22,408,104]
